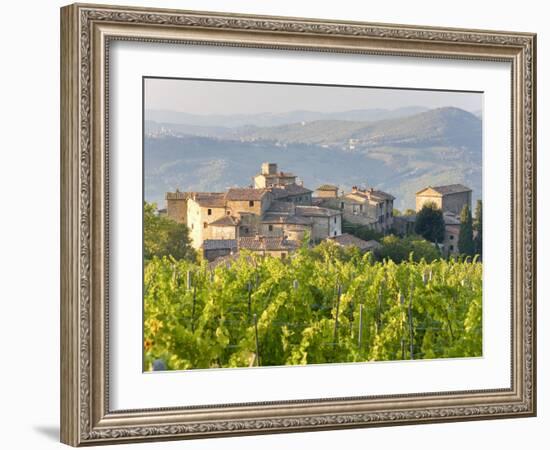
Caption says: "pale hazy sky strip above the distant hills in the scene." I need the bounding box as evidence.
[145,78,482,114]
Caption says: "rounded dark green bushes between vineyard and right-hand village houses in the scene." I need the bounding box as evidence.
[376,235,441,263]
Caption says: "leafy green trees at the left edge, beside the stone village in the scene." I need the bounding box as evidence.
[143,202,196,260]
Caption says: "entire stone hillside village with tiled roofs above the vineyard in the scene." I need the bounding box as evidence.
[161,162,472,262]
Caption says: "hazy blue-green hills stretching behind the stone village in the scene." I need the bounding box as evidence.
[144,108,482,209]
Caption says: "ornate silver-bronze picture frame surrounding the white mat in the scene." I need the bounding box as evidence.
[61,4,536,446]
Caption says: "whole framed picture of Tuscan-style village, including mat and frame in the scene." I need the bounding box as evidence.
[61,4,536,446]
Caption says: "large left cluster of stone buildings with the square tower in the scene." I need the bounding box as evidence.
[166,163,342,253]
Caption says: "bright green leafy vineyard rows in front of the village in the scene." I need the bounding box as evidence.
[144,243,482,370]
